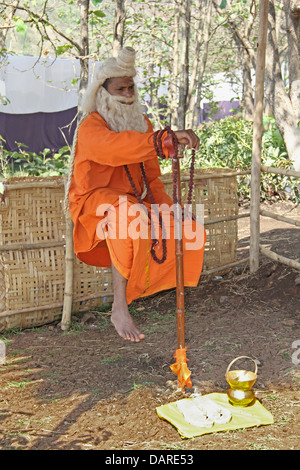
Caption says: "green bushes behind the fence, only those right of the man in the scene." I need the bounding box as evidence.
[161,117,300,203]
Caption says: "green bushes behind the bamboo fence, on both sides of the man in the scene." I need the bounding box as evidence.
[0,116,300,203]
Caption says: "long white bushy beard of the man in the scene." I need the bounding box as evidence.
[96,86,148,133]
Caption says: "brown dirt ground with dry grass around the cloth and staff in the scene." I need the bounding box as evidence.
[0,203,300,451]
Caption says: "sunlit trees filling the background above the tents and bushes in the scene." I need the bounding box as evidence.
[0,0,300,173]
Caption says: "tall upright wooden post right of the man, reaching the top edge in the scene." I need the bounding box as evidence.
[250,0,269,273]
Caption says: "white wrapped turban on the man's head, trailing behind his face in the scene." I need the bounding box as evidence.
[82,47,136,113]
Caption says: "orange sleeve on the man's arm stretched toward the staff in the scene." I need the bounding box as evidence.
[77,113,170,167]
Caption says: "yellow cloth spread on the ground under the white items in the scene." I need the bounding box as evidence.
[156,393,274,439]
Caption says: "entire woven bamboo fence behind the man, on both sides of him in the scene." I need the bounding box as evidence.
[0,169,238,331]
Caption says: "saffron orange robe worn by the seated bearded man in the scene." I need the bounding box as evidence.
[69,113,205,303]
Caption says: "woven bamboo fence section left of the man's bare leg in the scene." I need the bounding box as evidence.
[0,177,112,331]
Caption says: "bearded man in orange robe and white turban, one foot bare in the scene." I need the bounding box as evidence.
[68,48,205,342]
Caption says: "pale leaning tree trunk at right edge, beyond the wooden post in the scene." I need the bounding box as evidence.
[266,0,300,171]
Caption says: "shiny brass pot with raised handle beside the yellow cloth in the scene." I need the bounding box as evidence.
[225,356,257,406]
